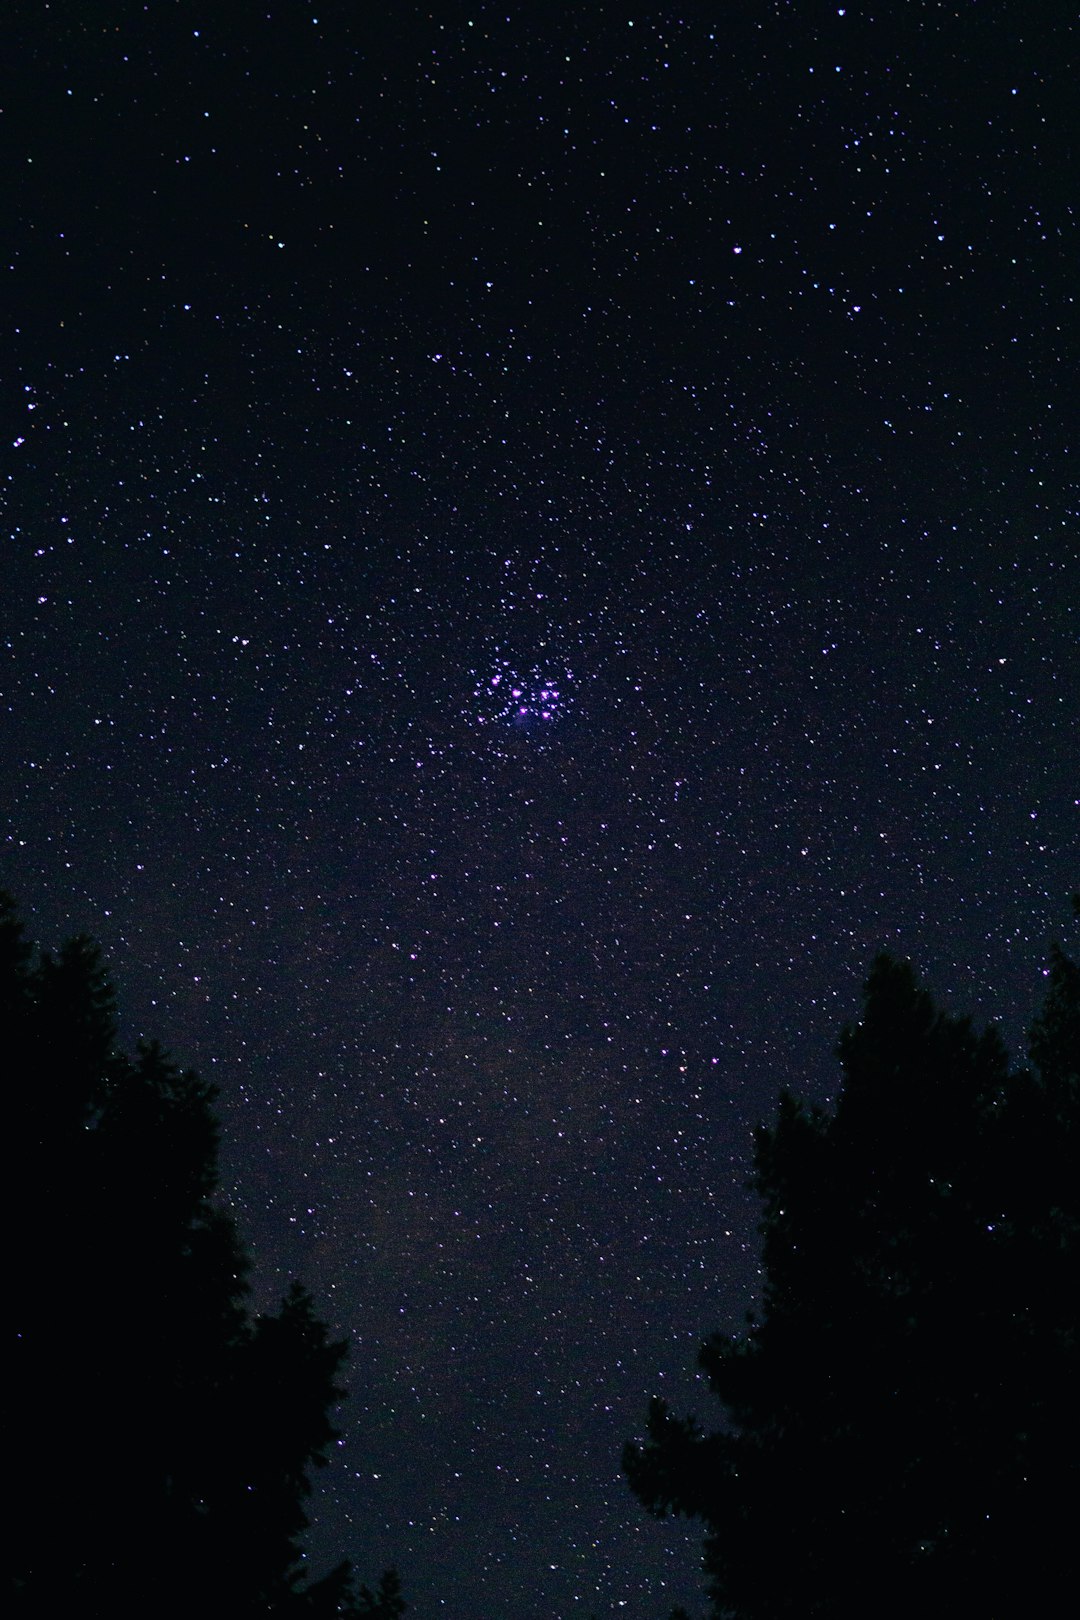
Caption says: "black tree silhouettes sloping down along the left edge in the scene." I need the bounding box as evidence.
[0,894,405,1620]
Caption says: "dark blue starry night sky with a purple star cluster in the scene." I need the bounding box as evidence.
[0,0,1080,1620]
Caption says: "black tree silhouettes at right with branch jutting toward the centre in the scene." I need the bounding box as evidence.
[623,920,1080,1620]
